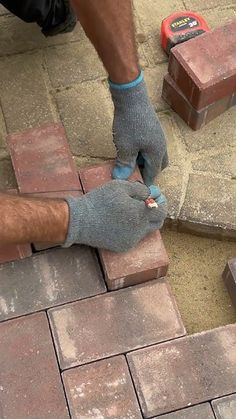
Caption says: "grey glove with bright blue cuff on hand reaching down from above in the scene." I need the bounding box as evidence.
[109,73,168,186]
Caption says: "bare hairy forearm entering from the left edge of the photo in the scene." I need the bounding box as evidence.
[0,193,69,244]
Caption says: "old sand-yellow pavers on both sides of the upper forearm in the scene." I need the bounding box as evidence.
[0,0,236,237]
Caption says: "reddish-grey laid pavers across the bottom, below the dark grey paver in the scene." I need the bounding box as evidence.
[0,306,236,419]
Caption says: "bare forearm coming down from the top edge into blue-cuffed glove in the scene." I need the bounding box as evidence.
[71,0,139,83]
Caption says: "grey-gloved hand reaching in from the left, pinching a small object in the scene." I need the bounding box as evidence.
[63,180,167,252]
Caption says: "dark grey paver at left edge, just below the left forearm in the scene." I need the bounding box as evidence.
[0,246,105,320]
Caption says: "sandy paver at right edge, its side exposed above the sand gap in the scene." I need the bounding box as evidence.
[179,174,236,239]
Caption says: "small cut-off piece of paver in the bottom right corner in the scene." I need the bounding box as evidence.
[211,393,236,419]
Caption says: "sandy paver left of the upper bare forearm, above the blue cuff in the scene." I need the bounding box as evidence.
[46,39,106,87]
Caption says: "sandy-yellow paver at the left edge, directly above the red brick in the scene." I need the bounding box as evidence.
[0,53,53,132]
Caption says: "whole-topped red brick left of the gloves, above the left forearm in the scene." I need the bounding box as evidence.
[7,124,81,193]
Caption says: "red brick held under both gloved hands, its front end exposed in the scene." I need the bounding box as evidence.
[79,163,169,290]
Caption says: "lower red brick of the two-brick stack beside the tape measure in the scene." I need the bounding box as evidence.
[162,74,236,130]
